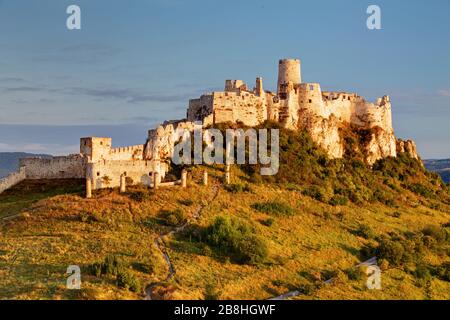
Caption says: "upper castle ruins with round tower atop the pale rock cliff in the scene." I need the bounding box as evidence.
[187,59,402,161]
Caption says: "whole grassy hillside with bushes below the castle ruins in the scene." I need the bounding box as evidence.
[0,130,450,299]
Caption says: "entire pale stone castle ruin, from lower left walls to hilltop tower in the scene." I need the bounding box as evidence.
[0,59,418,192]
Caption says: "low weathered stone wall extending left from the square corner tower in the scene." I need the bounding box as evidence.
[20,154,86,179]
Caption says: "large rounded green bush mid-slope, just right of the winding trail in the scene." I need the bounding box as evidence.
[205,217,268,264]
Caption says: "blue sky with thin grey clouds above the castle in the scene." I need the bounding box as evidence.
[0,0,450,158]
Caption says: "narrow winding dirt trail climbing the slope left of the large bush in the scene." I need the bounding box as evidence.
[144,185,219,300]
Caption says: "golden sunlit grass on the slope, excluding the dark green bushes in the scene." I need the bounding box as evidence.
[0,167,450,299]
